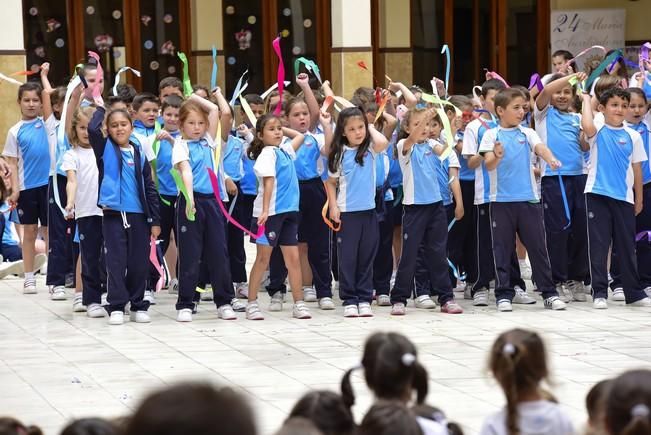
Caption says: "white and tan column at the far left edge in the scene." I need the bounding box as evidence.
[0,0,26,148]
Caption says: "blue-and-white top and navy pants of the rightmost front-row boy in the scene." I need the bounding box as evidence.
[585,124,648,303]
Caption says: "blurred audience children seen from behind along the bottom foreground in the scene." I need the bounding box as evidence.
[5,329,651,435]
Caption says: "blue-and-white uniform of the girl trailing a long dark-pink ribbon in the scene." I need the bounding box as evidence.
[172,134,235,310]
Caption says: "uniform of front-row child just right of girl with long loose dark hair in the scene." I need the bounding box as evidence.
[391,139,454,306]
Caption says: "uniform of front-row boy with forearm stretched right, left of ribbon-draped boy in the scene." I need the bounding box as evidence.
[479,127,558,303]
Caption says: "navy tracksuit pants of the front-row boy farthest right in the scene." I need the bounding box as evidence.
[586,193,648,304]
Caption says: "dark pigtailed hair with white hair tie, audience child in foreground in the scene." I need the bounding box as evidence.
[341,332,428,407]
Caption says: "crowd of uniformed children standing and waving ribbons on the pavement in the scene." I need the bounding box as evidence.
[0,46,651,324]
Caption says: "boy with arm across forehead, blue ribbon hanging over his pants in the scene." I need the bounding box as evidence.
[534,73,589,303]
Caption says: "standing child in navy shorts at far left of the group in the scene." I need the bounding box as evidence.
[2,82,50,296]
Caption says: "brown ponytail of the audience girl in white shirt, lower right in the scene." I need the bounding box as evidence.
[488,328,549,434]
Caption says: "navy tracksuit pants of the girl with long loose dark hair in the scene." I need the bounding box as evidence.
[337,209,379,306]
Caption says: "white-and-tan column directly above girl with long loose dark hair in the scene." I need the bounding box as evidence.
[330,0,373,98]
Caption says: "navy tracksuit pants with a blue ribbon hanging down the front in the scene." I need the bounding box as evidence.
[542,175,590,284]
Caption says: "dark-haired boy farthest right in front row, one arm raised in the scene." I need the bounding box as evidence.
[581,88,651,309]
